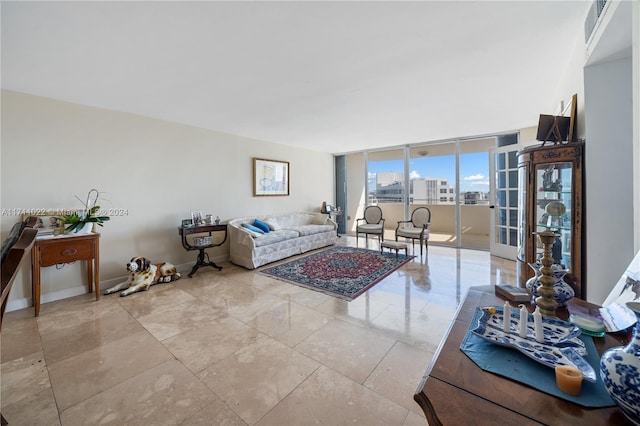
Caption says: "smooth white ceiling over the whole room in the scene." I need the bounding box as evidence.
[1,0,591,153]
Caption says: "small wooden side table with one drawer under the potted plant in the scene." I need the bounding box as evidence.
[31,233,100,316]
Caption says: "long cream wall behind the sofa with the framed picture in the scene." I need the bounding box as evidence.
[1,91,334,310]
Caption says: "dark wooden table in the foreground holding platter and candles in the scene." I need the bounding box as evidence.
[414,286,628,426]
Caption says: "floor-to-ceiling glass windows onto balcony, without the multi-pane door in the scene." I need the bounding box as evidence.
[346,133,516,250]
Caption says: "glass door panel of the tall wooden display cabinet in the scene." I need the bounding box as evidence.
[534,162,573,272]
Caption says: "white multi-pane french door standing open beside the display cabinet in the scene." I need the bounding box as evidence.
[489,144,521,260]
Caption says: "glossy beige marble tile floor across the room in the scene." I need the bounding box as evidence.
[0,236,515,426]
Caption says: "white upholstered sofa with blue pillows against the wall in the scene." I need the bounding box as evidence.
[228,213,338,269]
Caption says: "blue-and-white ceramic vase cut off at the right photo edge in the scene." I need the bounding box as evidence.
[600,302,640,426]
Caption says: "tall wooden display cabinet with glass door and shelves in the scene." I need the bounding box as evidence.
[517,142,586,299]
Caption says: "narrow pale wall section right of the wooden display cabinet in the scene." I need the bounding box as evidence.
[583,57,637,303]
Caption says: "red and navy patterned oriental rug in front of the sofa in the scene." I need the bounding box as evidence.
[259,246,413,301]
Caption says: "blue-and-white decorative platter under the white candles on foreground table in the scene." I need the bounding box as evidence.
[471,307,596,383]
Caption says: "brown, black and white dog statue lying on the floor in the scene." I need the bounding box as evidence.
[103,256,181,297]
